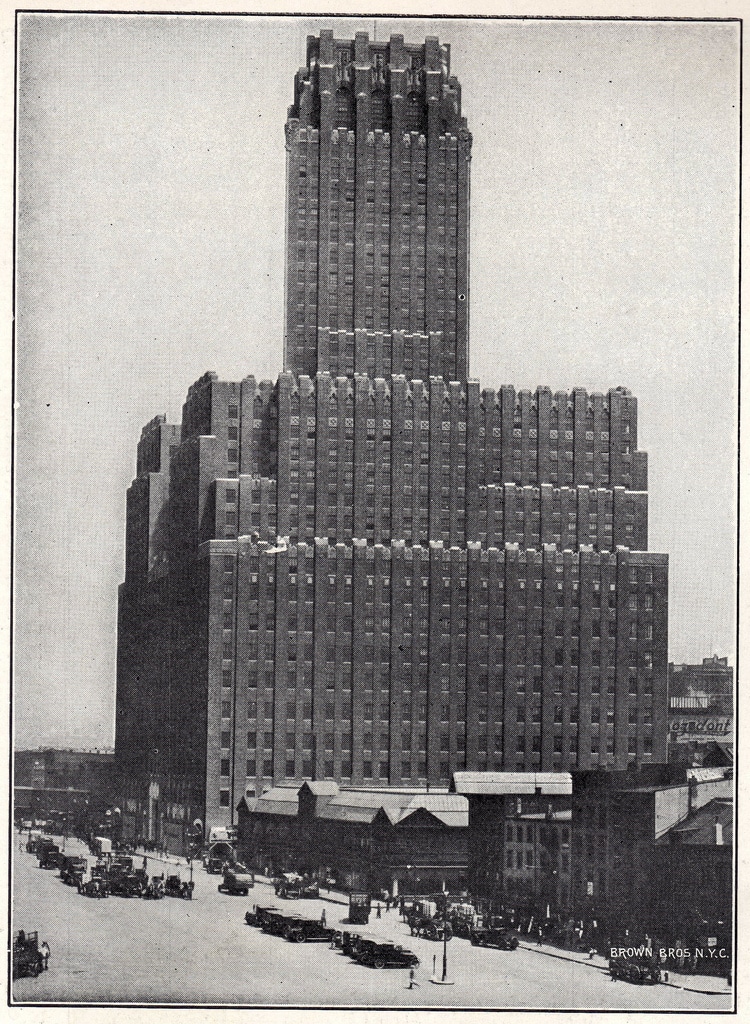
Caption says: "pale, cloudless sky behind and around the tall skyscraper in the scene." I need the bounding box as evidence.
[14,14,739,748]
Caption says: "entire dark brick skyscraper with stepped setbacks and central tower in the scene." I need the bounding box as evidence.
[112,32,667,844]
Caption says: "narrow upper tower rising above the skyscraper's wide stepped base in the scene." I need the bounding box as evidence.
[285,31,471,380]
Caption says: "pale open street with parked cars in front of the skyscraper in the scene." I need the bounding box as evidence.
[13,841,731,1012]
